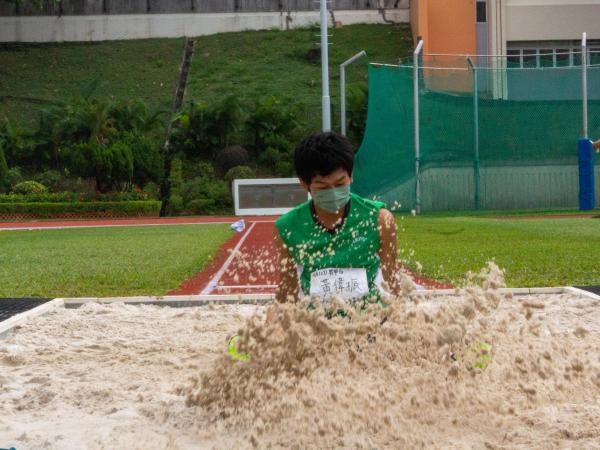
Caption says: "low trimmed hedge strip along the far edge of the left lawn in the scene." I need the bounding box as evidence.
[0,200,161,220]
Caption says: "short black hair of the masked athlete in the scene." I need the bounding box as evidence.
[294,132,354,184]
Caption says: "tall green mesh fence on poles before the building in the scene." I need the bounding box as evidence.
[353,58,600,211]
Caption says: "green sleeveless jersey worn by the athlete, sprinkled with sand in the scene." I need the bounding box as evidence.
[275,193,385,297]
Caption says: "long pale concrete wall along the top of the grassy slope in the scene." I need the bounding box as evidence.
[0,9,410,42]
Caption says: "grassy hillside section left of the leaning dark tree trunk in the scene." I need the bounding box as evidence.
[0,39,184,125]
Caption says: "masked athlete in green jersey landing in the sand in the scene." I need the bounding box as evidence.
[275,133,399,312]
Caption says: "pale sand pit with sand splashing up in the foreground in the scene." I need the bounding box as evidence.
[0,274,600,450]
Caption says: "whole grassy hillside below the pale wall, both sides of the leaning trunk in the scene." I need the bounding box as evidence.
[0,25,412,129]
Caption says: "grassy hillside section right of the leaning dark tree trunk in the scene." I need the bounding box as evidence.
[186,24,412,131]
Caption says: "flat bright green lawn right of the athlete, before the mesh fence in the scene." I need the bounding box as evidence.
[397,216,600,287]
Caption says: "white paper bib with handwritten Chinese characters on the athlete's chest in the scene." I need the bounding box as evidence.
[310,269,369,301]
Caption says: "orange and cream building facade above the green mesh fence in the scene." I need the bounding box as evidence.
[411,0,600,63]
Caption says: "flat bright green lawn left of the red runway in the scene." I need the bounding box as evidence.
[0,224,231,297]
